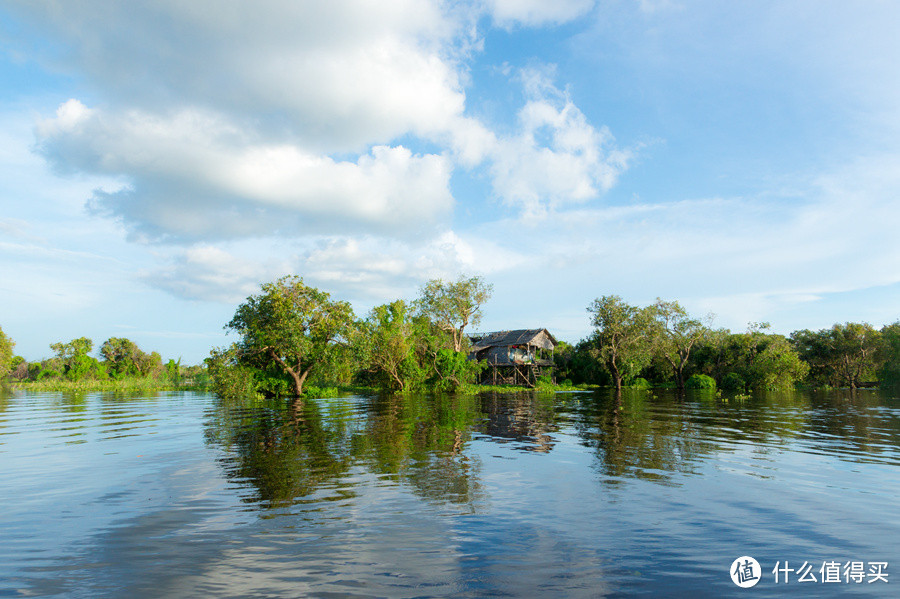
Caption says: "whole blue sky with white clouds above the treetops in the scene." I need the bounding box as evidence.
[0,0,900,363]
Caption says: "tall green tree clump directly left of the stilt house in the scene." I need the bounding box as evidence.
[206,276,492,397]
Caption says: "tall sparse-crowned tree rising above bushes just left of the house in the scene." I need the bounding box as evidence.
[416,276,493,352]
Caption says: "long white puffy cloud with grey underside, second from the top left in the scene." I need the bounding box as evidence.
[37,100,453,240]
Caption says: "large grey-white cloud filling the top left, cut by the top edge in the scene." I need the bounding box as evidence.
[10,0,468,152]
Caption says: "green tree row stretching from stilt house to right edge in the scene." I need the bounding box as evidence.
[554,295,900,392]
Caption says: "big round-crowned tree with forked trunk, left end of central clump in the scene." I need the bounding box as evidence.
[225,276,353,397]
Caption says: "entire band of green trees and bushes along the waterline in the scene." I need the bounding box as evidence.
[0,276,900,397]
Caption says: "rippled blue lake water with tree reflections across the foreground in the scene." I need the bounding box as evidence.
[0,391,900,598]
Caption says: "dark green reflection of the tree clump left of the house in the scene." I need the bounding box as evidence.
[206,395,481,507]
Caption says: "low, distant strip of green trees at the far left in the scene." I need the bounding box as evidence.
[0,330,205,384]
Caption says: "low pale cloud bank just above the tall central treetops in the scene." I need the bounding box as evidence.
[141,231,524,306]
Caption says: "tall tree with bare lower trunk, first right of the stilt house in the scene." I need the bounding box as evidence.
[587,295,654,393]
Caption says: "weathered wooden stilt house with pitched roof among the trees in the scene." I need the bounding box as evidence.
[469,329,557,387]
